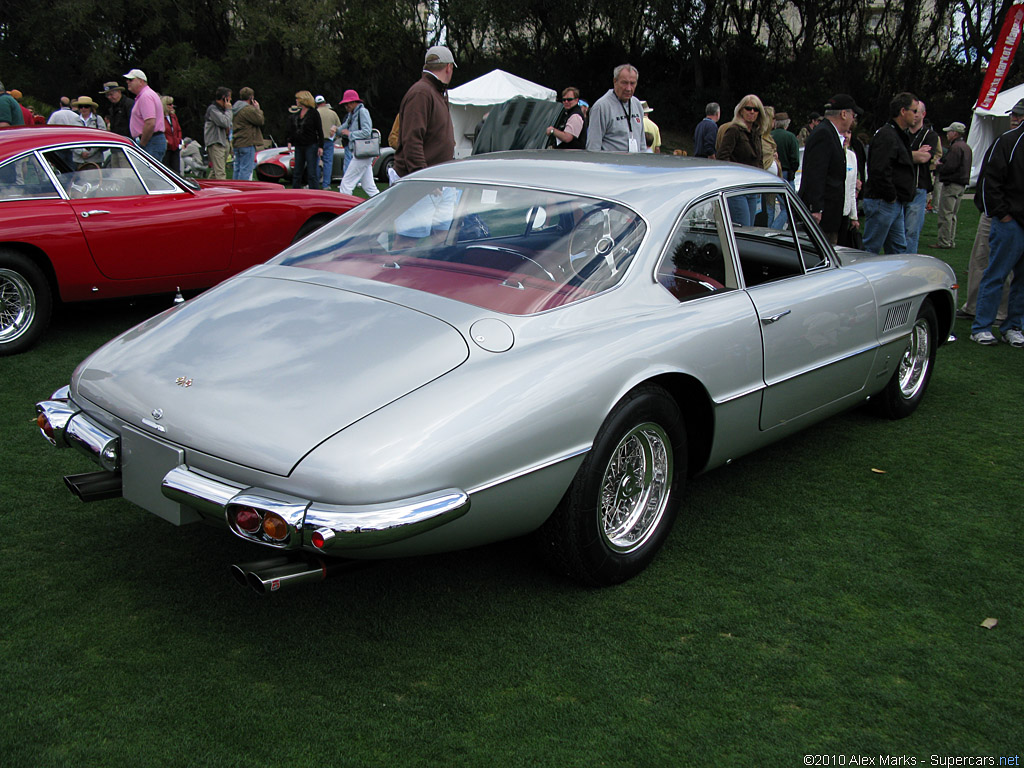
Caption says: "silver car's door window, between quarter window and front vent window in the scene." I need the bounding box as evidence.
[727,193,804,288]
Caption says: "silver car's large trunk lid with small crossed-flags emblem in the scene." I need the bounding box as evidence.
[73,276,469,475]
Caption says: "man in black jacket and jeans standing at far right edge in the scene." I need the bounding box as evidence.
[971,109,1024,347]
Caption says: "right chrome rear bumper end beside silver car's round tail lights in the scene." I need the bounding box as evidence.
[303,488,469,553]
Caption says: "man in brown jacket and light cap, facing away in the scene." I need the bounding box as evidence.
[393,45,455,177]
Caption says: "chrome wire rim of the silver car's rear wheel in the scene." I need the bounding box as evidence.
[599,422,672,552]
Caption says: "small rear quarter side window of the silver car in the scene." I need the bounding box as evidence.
[657,198,739,301]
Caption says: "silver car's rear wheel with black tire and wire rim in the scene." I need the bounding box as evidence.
[538,385,686,587]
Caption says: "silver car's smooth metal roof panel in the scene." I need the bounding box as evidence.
[410,150,781,207]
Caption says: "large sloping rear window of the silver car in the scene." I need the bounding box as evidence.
[271,181,646,314]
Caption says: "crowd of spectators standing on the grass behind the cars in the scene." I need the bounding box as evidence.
[0,54,1024,347]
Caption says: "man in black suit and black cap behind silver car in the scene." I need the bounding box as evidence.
[800,93,863,245]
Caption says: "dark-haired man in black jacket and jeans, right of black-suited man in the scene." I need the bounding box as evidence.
[863,92,920,253]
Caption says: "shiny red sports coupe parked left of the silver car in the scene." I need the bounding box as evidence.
[0,126,361,355]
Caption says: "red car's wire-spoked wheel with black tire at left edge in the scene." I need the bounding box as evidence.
[0,250,53,355]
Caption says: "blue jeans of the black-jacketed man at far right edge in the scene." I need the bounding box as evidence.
[971,218,1024,334]
